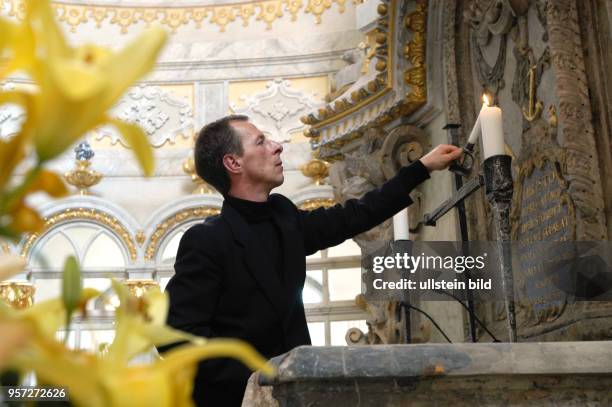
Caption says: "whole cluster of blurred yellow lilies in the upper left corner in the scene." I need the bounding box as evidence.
[0,0,166,239]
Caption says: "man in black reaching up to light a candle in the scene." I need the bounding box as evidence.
[166,116,461,407]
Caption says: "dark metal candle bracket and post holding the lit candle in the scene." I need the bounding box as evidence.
[415,124,517,342]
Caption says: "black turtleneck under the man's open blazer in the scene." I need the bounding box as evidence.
[225,195,283,282]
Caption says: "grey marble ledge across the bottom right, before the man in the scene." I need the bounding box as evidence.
[260,341,612,386]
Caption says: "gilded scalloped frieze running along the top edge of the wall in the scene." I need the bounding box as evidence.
[0,0,350,34]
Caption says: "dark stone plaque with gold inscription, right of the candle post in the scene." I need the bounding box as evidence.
[515,159,575,321]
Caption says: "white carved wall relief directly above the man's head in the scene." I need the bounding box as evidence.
[230,79,323,143]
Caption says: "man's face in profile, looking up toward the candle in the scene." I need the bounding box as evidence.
[230,121,284,190]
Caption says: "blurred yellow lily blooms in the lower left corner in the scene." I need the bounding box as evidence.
[0,261,274,407]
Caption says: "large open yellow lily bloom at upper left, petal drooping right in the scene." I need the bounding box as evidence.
[3,0,166,175]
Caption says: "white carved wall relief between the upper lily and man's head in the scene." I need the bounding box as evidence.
[96,85,194,147]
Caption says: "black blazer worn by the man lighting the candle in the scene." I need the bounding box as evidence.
[166,161,429,406]
